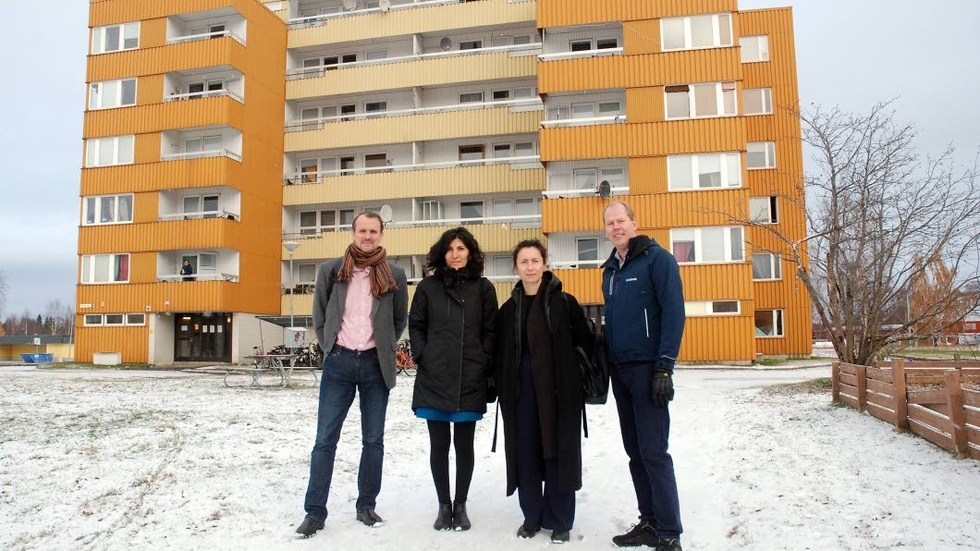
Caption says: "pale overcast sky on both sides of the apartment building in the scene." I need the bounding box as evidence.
[0,0,980,317]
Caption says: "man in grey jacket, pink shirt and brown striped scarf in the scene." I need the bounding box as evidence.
[296,212,408,538]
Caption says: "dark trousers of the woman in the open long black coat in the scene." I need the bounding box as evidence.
[516,355,575,531]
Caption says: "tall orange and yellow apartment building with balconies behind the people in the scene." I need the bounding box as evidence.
[76,0,811,363]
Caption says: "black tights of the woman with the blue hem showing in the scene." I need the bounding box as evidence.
[427,421,476,504]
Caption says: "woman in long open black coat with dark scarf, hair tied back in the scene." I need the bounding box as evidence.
[493,239,593,543]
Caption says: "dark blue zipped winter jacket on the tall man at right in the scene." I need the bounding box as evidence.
[602,235,685,374]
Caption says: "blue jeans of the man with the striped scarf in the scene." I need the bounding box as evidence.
[304,346,389,520]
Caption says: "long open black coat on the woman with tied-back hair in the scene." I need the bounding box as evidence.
[493,272,592,495]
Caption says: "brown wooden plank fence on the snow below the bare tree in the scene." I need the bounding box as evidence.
[832,359,980,459]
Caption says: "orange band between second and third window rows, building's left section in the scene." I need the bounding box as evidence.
[82,95,245,138]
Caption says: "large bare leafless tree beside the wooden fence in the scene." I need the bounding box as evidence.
[753,103,980,364]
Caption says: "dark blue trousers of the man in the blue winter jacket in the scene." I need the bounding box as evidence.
[612,364,683,537]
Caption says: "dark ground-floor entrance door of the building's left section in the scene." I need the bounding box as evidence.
[174,312,231,362]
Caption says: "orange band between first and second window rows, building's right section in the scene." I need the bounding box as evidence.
[538,48,742,95]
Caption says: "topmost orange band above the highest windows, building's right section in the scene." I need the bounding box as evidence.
[537,0,738,29]
